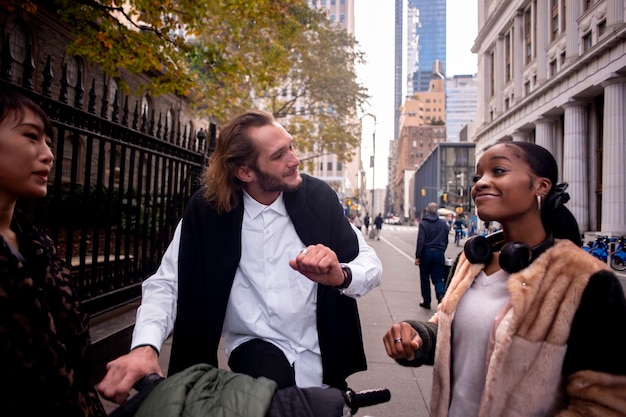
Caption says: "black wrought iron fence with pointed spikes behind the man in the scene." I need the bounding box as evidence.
[0,42,216,315]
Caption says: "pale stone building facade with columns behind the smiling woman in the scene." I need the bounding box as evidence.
[472,0,626,236]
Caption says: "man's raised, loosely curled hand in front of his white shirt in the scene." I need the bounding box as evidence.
[289,244,344,287]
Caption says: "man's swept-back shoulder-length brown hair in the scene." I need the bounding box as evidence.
[202,110,275,213]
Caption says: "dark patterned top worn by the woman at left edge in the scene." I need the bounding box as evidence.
[0,213,106,417]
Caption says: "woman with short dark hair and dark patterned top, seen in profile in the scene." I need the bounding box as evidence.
[0,91,106,417]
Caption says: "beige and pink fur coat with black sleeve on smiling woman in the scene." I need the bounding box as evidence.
[399,240,626,417]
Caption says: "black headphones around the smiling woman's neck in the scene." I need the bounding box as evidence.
[463,230,554,274]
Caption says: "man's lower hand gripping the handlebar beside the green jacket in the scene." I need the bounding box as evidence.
[98,346,163,404]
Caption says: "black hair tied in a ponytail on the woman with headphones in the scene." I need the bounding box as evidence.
[504,142,582,246]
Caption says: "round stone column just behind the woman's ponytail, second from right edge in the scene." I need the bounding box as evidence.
[563,100,589,232]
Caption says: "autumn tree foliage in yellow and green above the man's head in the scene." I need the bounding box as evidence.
[8,0,367,164]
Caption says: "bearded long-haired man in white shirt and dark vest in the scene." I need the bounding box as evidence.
[98,111,382,402]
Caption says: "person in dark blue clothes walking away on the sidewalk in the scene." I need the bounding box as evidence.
[415,202,448,310]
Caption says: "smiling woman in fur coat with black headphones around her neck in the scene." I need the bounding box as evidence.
[383,142,626,417]
